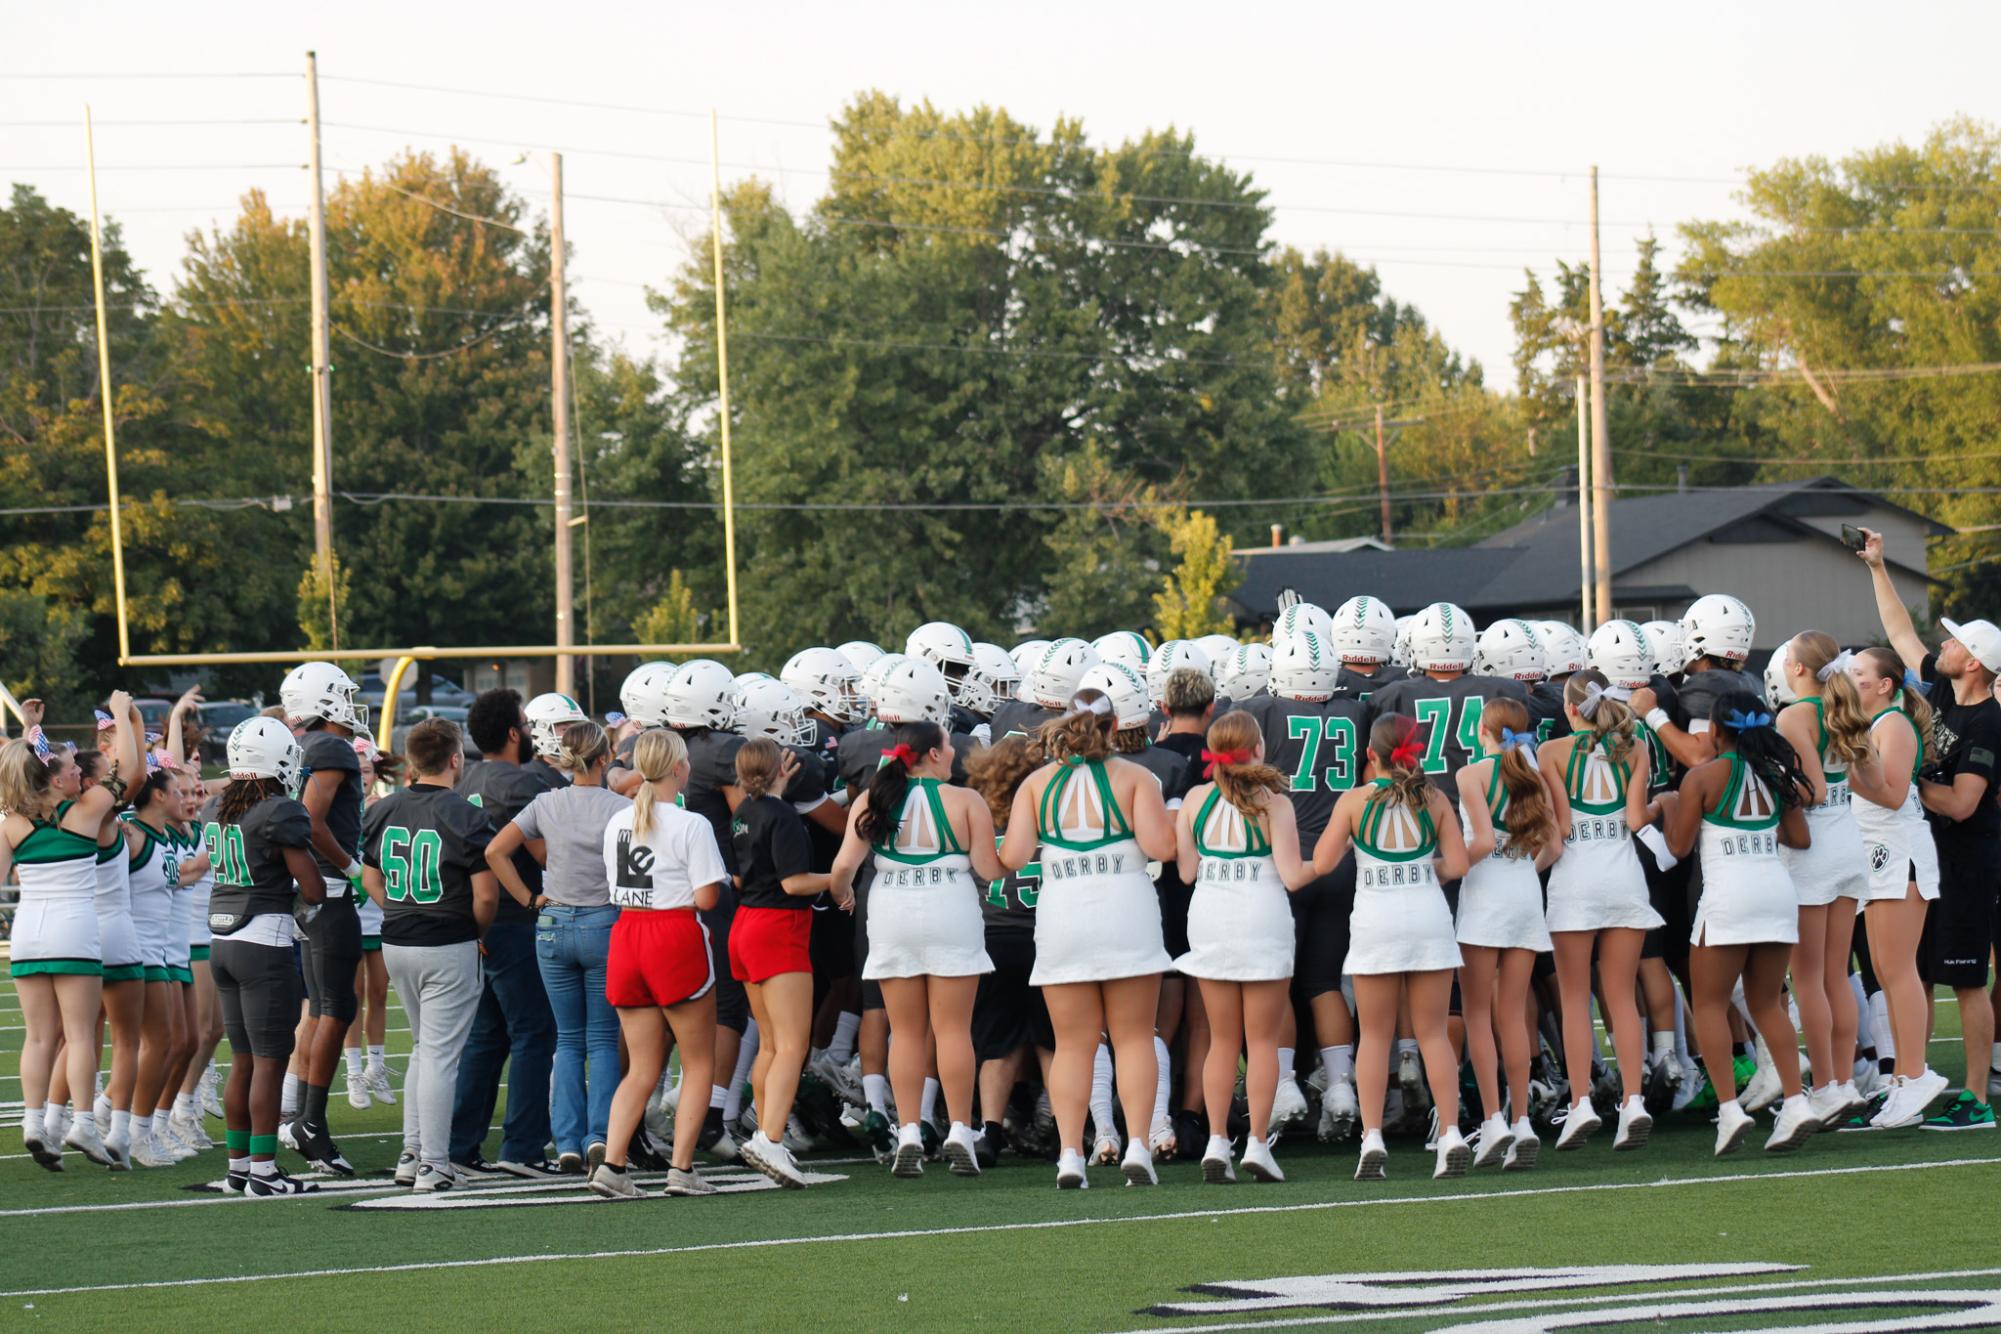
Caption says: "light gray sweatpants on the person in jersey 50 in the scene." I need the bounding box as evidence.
[382,940,484,1172]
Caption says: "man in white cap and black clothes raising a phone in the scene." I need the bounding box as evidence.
[1843,528,2001,1130]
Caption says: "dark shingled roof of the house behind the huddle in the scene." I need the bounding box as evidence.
[1235,478,1951,616]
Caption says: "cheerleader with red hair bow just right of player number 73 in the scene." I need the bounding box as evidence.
[1313,714,1473,1182]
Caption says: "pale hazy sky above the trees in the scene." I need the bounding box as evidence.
[0,0,2001,386]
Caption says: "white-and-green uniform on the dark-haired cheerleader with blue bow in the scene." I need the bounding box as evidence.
[1689,754,1799,946]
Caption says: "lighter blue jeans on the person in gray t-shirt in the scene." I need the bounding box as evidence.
[534,904,618,1154]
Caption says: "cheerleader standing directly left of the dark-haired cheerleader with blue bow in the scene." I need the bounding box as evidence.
[1541,670,1661,1150]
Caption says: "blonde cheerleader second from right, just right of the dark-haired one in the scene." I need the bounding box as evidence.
[1775,630,1875,1130]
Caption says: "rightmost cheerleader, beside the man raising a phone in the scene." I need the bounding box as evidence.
[1849,648,1945,1130]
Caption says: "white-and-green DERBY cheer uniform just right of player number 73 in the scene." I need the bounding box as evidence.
[1347,778,1463,976]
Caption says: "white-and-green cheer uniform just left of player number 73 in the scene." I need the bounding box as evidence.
[1175,788,1293,982]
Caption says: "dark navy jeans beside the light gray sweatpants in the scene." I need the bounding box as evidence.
[452,922,556,1162]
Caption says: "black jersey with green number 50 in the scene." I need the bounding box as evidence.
[362,784,490,946]
